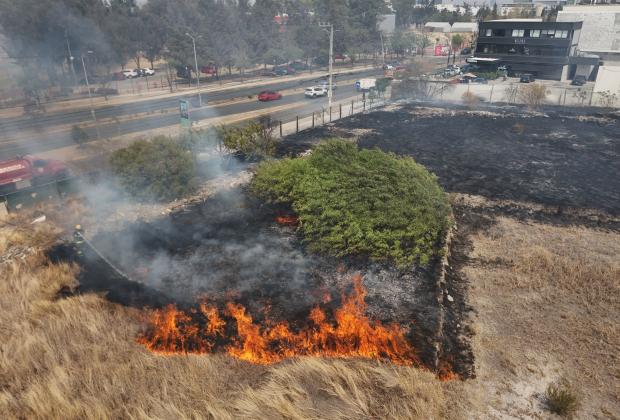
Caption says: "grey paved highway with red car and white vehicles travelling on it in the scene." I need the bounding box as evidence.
[0,70,377,159]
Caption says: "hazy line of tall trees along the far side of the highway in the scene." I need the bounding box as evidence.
[0,0,388,85]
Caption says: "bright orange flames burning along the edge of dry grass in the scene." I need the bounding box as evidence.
[138,274,420,366]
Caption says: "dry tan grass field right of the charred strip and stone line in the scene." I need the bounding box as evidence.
[451,217,620,419]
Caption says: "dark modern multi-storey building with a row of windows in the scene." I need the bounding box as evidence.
[467,19,598,80]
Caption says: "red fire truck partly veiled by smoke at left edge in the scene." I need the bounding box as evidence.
[0,155,70,194]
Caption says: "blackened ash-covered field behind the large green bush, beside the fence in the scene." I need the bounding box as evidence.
[280,105,620,215]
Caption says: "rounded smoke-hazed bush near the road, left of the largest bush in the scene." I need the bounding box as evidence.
[110,136,196,200]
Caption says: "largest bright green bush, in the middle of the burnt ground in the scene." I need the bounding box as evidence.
[251,140,450,268]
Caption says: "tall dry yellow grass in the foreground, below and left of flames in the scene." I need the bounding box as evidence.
[0,217,444,420]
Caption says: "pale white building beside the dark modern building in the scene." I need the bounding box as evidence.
[557,5,620,52]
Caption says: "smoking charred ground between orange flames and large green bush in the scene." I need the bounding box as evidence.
[53,188,453,369]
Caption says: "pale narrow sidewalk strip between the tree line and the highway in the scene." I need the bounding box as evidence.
[0,66,376,118]
